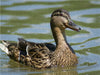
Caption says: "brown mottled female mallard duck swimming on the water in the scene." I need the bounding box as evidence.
[0,9,81,68]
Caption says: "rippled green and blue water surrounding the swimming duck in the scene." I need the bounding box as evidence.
[0,0,100,75]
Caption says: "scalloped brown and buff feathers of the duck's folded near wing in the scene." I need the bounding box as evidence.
[26,43,51,68]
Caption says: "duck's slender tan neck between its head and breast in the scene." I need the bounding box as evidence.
[51,26,75,54]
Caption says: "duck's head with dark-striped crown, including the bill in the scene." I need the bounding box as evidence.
[50,9,81,31]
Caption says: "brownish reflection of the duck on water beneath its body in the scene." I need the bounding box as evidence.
[2,60,78,75]
